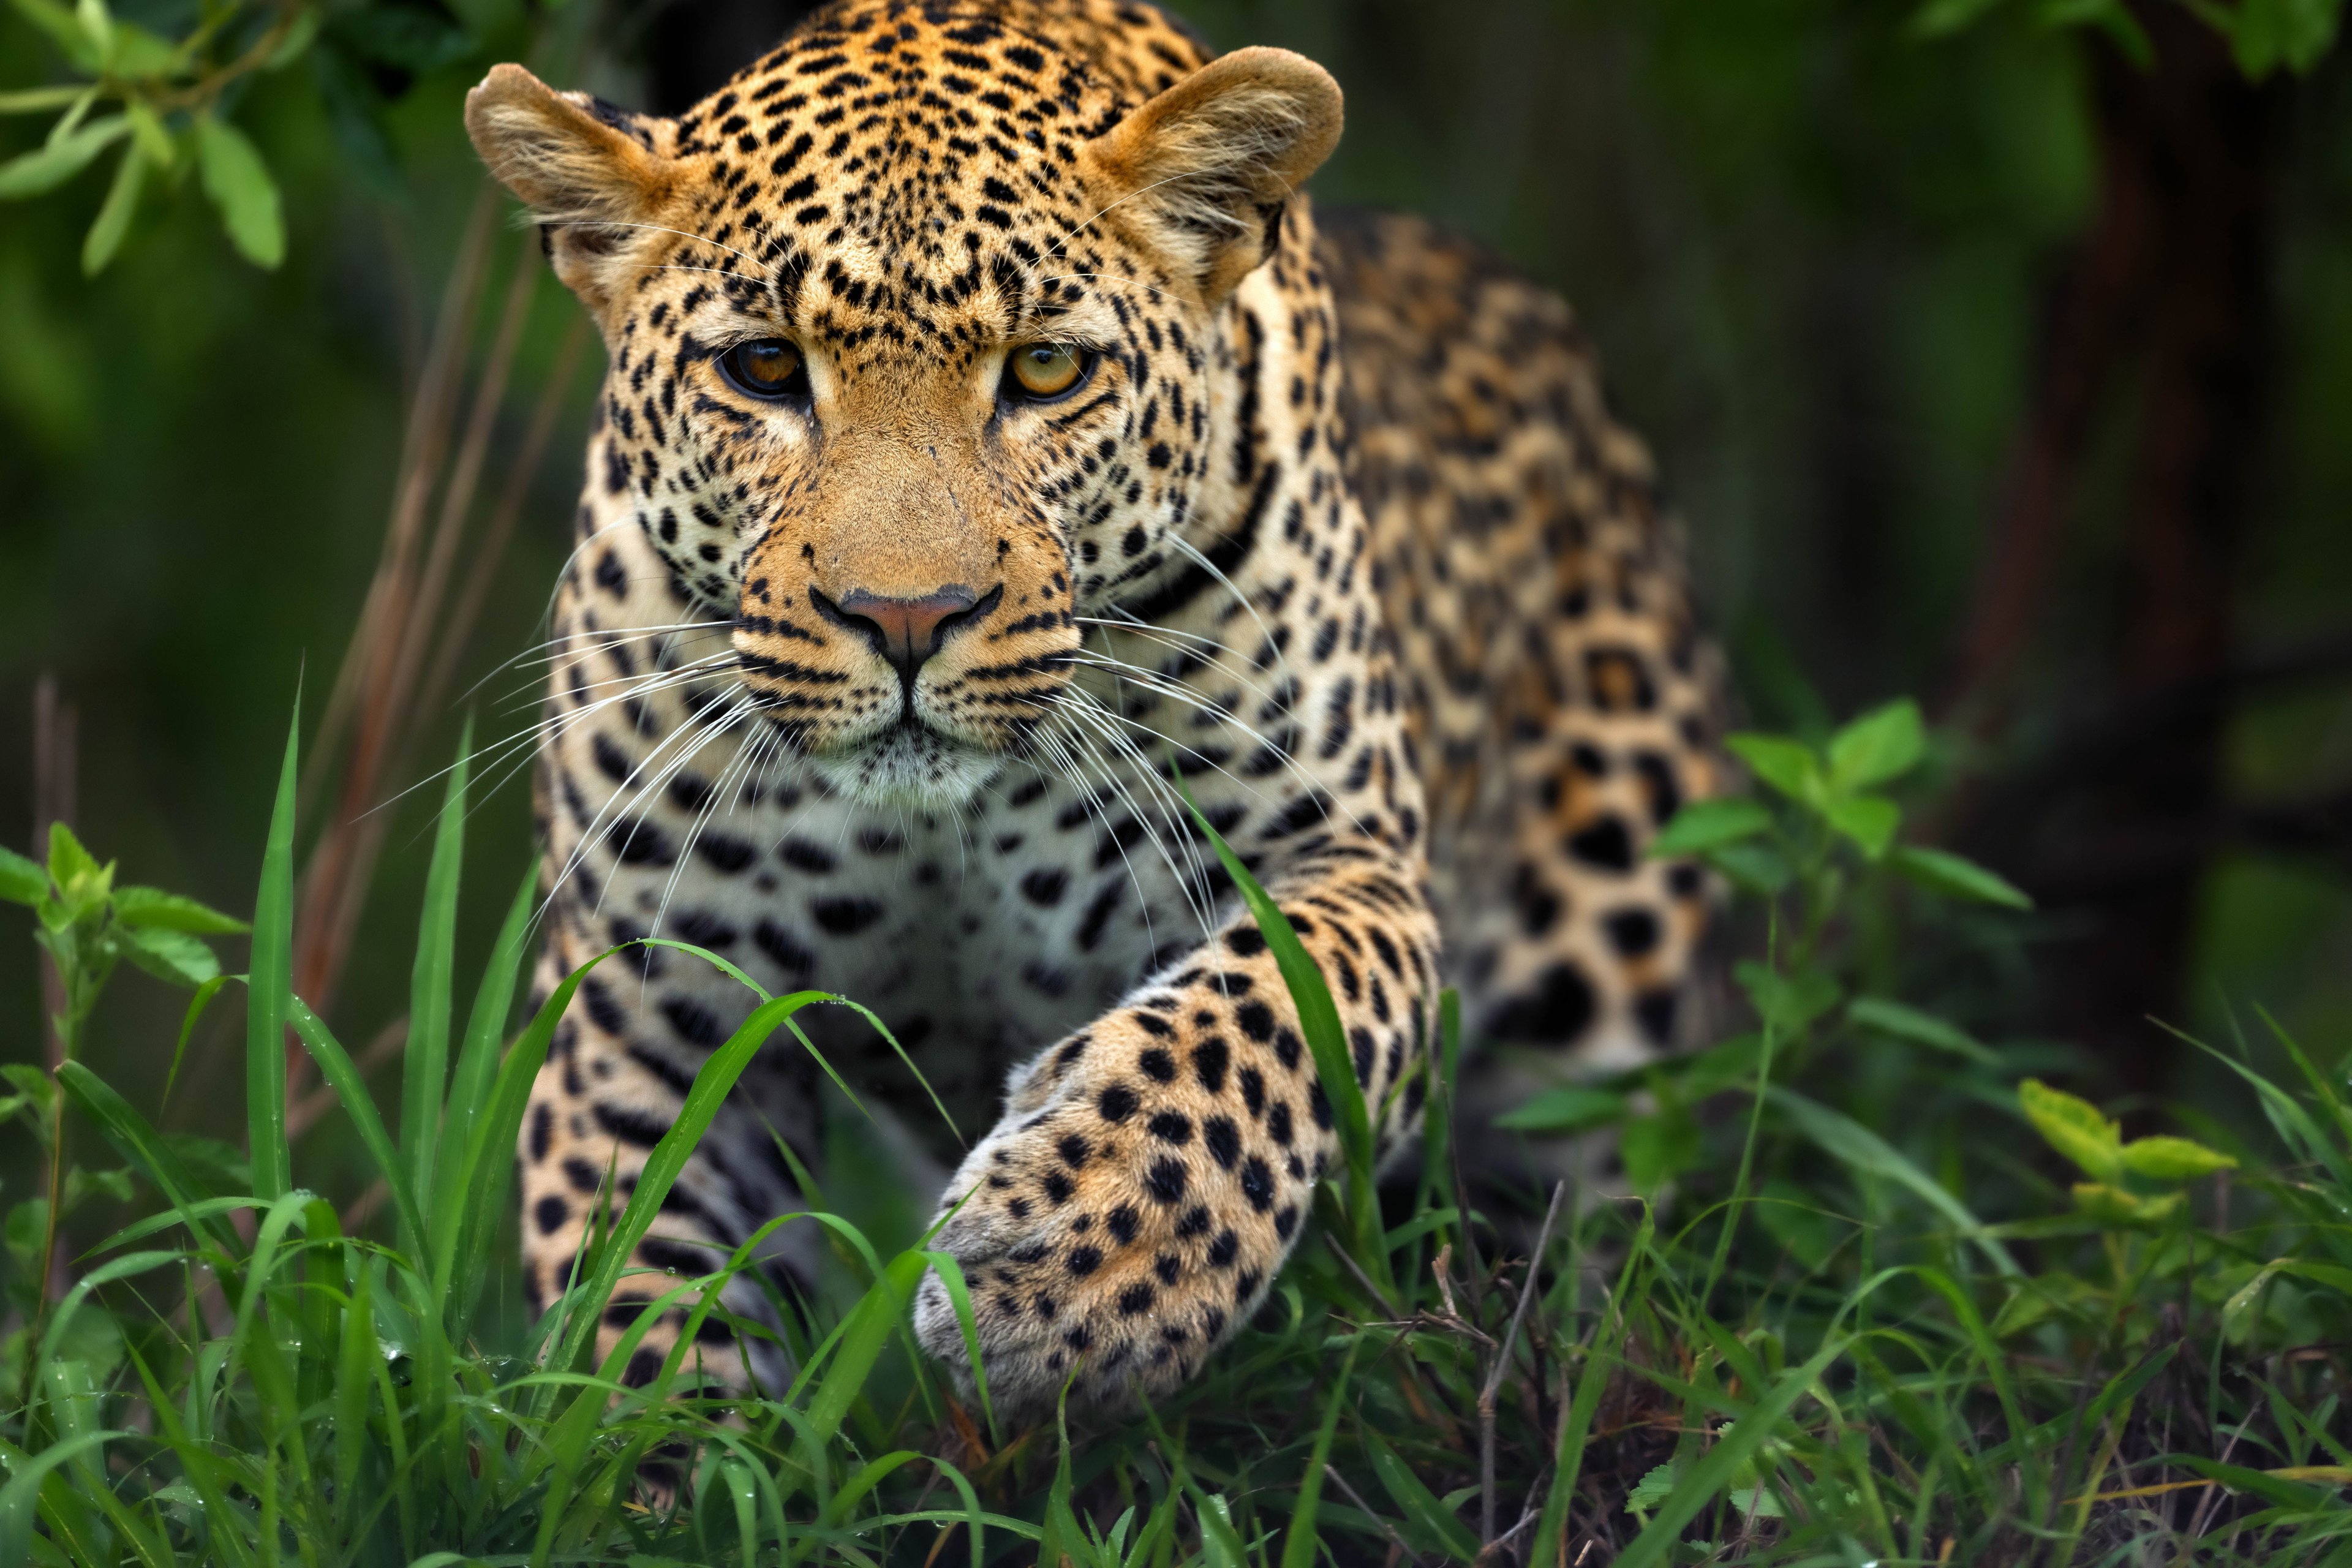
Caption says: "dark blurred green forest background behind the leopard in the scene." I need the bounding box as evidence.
[0,0,2352,1183]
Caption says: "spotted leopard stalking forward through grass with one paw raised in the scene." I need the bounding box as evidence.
[466,0,1724,1417]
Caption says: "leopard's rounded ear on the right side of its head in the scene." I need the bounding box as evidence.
[1087,50,1343,306]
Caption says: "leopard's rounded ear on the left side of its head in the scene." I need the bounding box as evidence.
[466,66,675,308]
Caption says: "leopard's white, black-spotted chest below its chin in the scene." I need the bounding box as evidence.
[543,701,1204,1124]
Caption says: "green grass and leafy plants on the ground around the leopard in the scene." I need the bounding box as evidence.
[0,710,2352,1568]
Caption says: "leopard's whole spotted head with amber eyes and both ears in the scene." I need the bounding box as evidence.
[468,5,1341,806]
